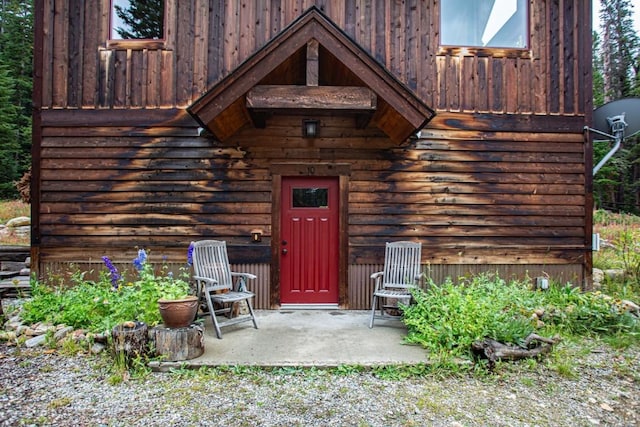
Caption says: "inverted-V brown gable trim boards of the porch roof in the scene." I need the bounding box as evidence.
[188,6,435,143]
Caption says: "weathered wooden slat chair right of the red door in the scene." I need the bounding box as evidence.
[369,242,422,328]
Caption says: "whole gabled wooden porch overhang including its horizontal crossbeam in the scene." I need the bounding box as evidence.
[188,6,435,143]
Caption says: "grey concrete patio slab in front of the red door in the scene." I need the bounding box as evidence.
[152,310,427,370]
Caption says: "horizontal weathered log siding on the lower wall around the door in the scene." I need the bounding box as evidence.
[36,111,586,308]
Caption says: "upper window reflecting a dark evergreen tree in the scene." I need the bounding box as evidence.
[111,0,165,41]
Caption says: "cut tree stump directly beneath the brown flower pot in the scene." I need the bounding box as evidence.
[150,324,204,362]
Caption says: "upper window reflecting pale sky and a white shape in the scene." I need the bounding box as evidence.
[440,0,529,49]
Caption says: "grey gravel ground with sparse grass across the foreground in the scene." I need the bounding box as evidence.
[0,344,640,426]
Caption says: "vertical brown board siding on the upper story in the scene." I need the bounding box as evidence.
[36,0,591,115]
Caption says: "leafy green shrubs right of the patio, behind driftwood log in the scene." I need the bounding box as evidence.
[403,274,640,360]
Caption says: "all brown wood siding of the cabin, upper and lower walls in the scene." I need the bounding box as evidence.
[33,0,591,309]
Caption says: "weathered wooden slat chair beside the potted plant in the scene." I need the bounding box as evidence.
[193,240,258,339]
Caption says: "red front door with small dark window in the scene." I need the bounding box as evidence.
[280,177,339,304]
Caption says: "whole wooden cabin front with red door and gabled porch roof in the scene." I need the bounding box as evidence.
[31,0,592,309]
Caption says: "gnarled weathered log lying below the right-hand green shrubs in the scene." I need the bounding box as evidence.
[471,334,560,369]
